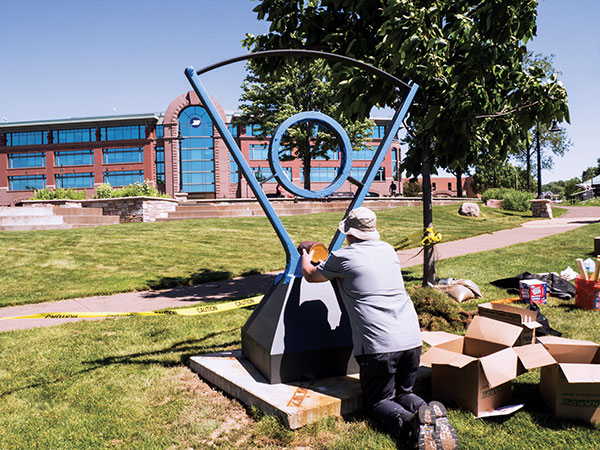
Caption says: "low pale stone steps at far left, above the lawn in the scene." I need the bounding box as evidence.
[0,206,119,231]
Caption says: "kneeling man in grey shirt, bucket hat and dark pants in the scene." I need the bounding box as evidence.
[302,207,458,449]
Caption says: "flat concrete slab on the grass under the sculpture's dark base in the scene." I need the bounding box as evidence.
[190,350,362,430]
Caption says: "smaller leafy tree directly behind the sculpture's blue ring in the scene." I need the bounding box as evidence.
[236,58,375,189]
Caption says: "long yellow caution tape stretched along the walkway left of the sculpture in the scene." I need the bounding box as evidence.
[0,295,263,320]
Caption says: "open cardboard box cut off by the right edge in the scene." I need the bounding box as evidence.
[539,336,600,423]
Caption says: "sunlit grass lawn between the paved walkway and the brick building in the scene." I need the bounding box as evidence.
[0,205,531,307]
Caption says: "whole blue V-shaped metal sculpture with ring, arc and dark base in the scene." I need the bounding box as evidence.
[185,50,418,383]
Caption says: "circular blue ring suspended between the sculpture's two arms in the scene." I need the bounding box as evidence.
[269,111,352,198]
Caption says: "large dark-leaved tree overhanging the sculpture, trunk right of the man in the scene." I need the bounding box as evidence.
[246,0,568,284]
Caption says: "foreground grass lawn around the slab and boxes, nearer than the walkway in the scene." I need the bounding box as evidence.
[0,219,600,450]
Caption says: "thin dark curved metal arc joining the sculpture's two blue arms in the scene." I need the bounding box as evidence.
[196,49,411,89]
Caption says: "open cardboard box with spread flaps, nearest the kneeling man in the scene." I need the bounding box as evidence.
[421,316,555,417]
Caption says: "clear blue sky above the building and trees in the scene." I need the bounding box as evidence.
[0,0,600,182]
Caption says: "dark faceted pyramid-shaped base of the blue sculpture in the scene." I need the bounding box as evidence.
[242,277,358,383]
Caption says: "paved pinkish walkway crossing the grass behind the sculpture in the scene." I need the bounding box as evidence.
[0,207,600,332]
